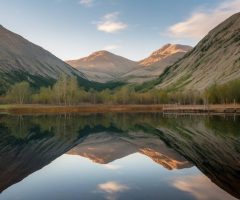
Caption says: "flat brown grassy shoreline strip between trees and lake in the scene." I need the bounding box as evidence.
[0,104,240,114]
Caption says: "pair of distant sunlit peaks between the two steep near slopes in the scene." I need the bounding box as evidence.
[66,44,192,82]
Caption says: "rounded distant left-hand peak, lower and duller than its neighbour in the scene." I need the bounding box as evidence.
[66,51,139,82]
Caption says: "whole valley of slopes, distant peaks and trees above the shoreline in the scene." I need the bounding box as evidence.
[0,13,240,107]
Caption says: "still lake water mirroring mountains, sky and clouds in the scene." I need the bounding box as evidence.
[0,113,240,200]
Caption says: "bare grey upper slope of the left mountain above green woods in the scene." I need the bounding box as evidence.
[0,25,83,78]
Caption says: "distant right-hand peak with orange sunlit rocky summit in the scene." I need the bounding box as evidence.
[123,44,192,82]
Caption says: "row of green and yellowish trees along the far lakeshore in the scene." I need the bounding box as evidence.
[1,75,240,105]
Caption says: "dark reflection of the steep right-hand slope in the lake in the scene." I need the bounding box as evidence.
[159,116,240,199]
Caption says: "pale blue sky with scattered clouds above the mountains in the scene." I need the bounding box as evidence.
[0,0,240,61]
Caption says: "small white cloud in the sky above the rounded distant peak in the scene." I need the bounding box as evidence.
[97,12,127,33]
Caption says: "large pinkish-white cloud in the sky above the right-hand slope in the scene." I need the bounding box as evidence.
[168,0,240,39]
